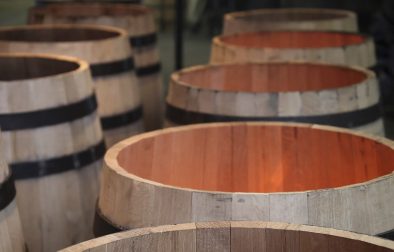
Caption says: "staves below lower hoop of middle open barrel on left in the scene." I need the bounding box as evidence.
[104,119,144,148]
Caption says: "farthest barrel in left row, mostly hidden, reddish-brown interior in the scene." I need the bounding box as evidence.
[29,2,164,130]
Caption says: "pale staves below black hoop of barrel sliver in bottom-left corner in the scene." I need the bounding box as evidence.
[0,200,26,252]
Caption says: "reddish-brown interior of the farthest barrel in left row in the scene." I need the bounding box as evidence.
[32,2,151,18]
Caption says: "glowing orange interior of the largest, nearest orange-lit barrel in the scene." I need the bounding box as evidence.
[117,124,394,193]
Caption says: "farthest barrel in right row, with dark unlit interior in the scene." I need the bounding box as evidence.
[223,8,358,35]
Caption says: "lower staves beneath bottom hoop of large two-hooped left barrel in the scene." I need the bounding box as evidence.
[16,160,102,252]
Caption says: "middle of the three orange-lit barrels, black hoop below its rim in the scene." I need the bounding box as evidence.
[166,62,384,136]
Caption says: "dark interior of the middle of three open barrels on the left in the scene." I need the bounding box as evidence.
[0,26,120,42]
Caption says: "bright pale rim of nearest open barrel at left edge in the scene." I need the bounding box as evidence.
[0,52,90,84]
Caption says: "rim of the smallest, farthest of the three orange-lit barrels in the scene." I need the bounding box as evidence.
[212,29,373,50]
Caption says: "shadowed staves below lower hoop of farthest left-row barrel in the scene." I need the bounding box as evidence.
[139,74,164,131]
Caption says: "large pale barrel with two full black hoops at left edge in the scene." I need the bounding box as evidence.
[0,54,105,252]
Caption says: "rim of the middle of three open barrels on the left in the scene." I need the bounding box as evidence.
[0,24,128,45]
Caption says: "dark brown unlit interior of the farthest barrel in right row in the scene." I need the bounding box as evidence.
[233,10,347,23]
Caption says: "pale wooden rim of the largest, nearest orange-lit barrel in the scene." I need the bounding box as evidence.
[104,122,394,195]
